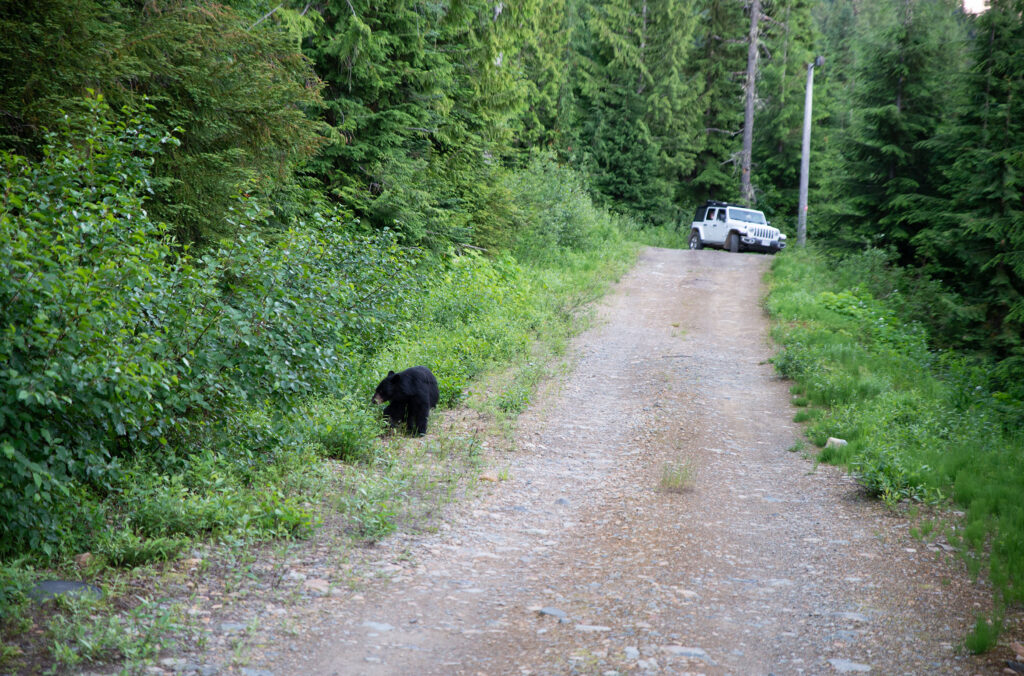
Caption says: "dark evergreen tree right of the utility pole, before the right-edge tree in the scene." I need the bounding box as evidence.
[833,0,963,263]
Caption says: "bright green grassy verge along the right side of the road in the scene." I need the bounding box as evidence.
[766,243,1024,651]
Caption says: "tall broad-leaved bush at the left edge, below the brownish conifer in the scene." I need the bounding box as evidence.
[0,98,177,553]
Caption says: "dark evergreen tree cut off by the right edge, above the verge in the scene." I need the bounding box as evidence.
[913,0,1024,356]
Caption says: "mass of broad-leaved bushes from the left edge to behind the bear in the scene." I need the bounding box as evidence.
[0,98,415,555]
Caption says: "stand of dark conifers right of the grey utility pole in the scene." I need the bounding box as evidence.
[809,0,1024,368]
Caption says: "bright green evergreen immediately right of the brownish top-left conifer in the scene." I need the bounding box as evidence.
[305,0,455,240]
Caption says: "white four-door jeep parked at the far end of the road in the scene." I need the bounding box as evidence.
[690,200,785,254]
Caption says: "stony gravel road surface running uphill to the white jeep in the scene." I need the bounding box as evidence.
[248,249,997,676]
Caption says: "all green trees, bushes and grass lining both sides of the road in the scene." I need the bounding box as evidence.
[0,0,1024,670]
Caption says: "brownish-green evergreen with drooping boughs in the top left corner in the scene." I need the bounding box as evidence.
[0,0,319,242]
